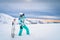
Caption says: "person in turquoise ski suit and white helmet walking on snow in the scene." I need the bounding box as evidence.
[19,13,29,36]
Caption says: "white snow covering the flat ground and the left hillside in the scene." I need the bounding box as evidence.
[0,14,60,40]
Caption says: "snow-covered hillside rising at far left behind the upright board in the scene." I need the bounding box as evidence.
[0,13,13,24]
